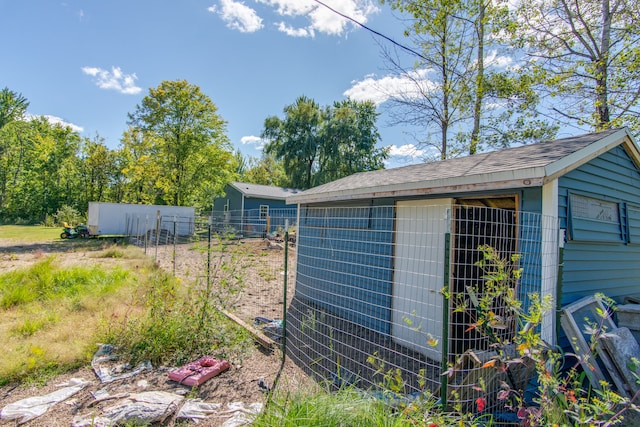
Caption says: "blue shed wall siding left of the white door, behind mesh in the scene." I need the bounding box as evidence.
[296,207,393,334]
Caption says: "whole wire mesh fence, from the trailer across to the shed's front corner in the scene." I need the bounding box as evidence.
[125,201,558,418]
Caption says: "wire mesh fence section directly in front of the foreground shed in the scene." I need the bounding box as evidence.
[287,205,557,422]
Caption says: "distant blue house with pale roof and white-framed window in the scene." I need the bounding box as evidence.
[213,182,299,235]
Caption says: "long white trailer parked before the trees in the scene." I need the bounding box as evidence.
[87,202,195,236]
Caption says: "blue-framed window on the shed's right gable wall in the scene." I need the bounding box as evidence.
[569,194,626,242]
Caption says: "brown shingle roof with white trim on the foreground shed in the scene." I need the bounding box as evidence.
[287,129,637,203]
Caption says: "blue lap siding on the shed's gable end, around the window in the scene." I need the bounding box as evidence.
[558,146,640,305]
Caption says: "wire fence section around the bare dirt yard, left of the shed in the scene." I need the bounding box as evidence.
[128,209,296,342]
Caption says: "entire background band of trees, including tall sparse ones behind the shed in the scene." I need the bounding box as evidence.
[0,0,640,221]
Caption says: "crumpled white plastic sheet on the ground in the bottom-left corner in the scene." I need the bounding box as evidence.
[0,378,90,424]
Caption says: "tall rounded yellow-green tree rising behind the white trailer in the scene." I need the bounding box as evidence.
[129,80,235,207]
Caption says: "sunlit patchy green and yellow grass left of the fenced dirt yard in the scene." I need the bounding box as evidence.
[0,234,254,386]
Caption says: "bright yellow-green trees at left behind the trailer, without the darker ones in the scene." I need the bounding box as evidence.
[0,81,236,222]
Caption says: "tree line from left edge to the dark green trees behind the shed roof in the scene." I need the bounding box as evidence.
[0,80,387,222]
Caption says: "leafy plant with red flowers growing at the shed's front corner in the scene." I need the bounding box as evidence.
[446,246,637,426]
